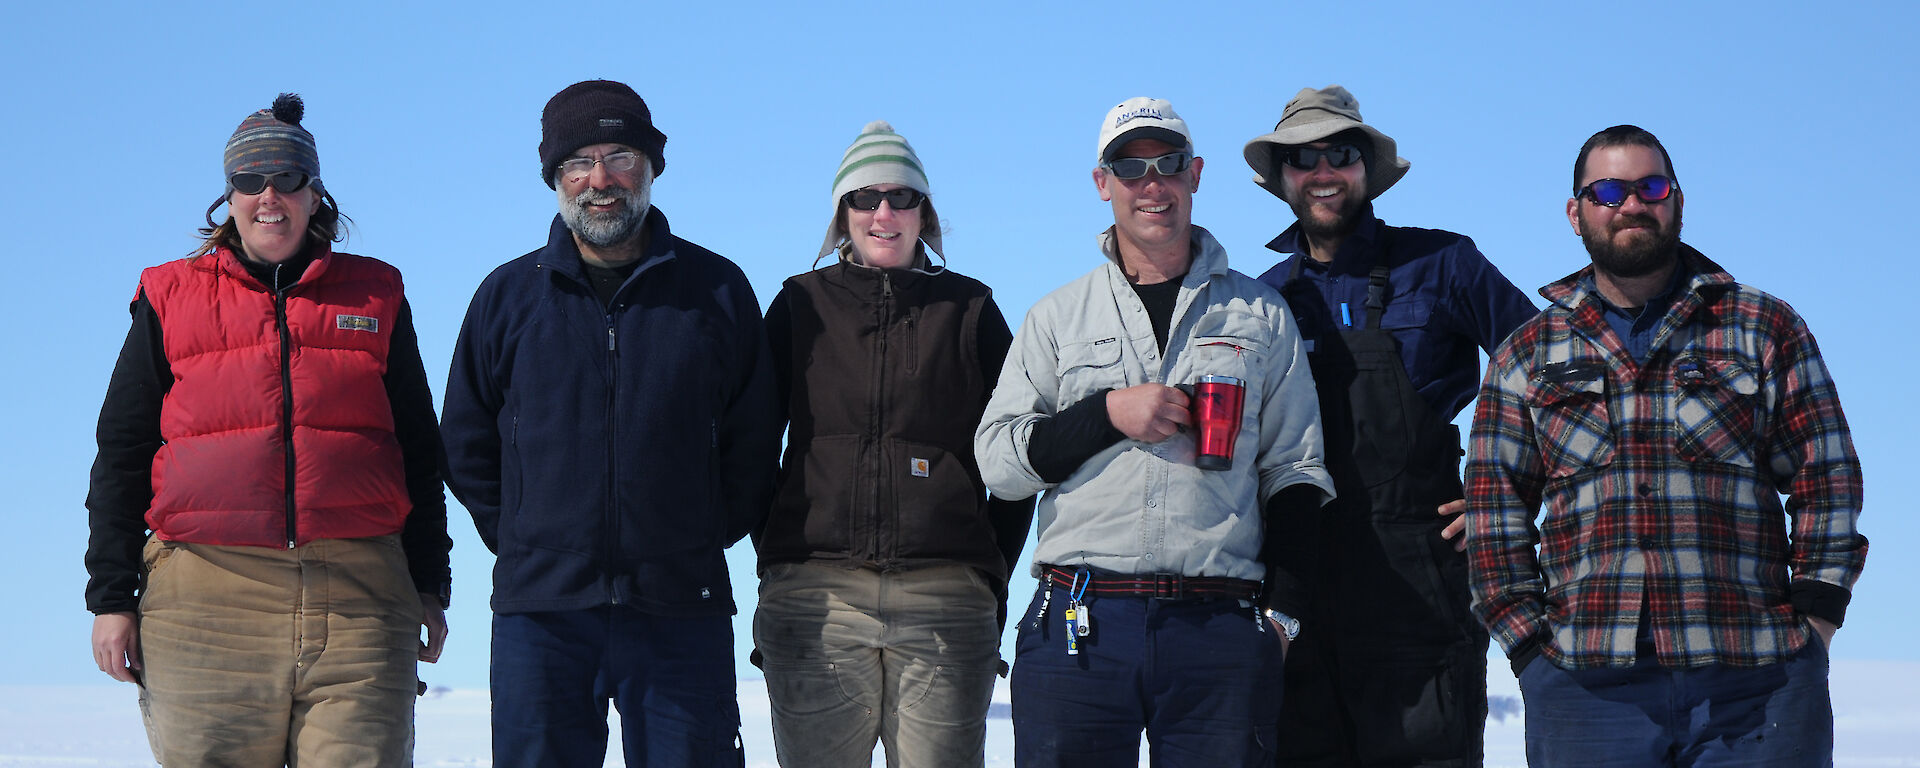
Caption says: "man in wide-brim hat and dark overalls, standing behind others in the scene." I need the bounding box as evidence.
[1244,84,1534,766]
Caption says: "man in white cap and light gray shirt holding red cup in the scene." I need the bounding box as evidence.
[973,98,1332,766]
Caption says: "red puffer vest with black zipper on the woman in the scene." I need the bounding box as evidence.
[140,250,411,547]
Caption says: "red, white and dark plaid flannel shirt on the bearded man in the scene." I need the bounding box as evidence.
[1467,246,1866,668]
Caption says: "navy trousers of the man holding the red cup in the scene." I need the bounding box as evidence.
[1008,582,1283,768]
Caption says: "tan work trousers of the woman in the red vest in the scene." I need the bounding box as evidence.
[140,536,420,766]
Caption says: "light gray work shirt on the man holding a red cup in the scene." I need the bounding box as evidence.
[973,227,1334,582]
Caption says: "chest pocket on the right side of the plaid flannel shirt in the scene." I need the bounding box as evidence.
[1674,355,1761,467]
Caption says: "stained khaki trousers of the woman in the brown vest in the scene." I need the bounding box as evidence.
[755,563,1000,768]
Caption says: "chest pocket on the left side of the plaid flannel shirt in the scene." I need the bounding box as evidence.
[1526,361,1613,478]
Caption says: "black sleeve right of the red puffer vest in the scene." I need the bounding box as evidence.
[382,300,453,609]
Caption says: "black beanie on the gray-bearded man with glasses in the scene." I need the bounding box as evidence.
[540,81,666,188]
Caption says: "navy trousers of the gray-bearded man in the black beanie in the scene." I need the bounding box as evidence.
[492,605,745,766]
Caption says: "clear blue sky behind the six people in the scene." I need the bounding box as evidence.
[0,2,1920,687]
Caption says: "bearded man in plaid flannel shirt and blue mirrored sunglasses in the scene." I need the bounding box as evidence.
[1467,125,1866,766]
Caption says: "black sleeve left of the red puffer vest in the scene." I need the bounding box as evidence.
[86,294,173,614]
